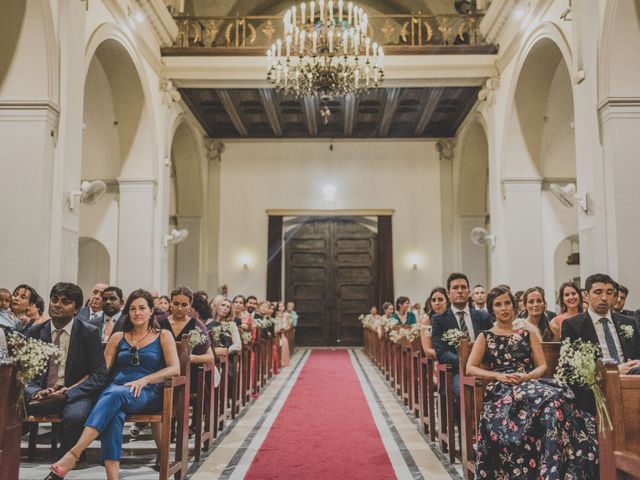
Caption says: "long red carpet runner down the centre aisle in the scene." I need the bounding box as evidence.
[245,350,396,480]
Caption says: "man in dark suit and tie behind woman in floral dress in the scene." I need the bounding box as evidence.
[432,273,493,411]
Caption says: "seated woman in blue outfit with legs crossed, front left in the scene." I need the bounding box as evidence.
[45,290,180,480]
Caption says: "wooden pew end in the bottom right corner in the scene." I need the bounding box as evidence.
[598,360,640,480]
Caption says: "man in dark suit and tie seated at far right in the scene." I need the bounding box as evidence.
[562,273,640,413]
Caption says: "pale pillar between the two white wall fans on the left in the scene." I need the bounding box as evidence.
[116,178,156,293]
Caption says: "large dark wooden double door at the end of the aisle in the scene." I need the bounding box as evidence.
[285,217,378,346]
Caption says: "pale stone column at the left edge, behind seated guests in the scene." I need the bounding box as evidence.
[0,99,59,296]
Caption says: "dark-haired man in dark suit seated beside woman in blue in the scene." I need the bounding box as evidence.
[25,283,108,455]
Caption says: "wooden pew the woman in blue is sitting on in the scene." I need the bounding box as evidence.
[126,334,191,480]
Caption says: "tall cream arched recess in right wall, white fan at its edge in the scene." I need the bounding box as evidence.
[502,38,578,303]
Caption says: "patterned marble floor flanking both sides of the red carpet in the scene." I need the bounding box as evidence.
[20,348,462,480]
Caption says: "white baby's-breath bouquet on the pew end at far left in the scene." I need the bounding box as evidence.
[7,333,62,416]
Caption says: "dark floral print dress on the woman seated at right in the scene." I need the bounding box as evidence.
[476,330,598,480]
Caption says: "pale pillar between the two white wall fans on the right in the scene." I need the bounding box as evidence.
[502,178,544,292]
